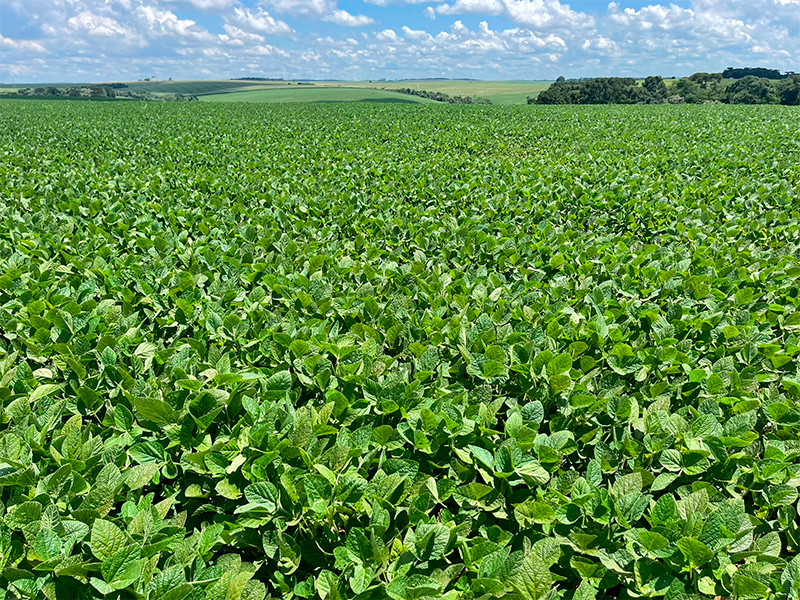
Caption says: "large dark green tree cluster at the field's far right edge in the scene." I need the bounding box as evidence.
[528,69,800,106]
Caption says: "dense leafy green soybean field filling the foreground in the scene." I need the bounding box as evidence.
[0,101,800,600]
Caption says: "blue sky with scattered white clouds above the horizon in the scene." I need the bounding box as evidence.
[0,0,800,83]
